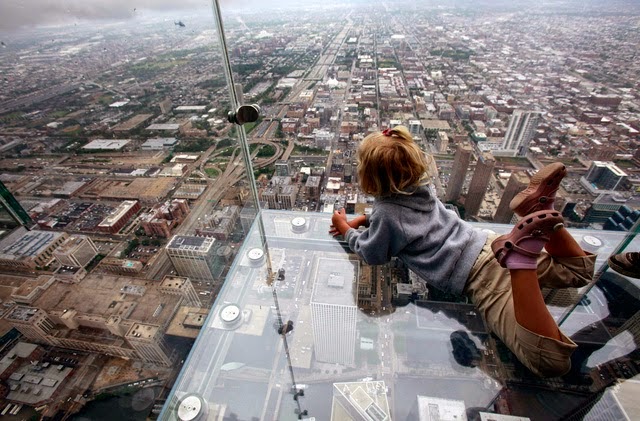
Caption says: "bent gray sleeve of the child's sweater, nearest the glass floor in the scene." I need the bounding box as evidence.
[345,210,407,265]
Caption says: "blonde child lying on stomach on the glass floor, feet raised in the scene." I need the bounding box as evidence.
[329,126,595,377]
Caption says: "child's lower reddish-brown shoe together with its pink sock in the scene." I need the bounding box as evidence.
[491,210,564,269]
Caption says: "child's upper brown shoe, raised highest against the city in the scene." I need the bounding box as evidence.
[509,162,567,217]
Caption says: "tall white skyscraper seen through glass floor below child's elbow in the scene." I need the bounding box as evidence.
[311,254,359,365]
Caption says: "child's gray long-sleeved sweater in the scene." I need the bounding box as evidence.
[345,186,487,294]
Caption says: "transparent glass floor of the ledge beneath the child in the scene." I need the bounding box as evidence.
[160,210,640,420]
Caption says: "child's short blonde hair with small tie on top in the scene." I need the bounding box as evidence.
[358,126,431,197]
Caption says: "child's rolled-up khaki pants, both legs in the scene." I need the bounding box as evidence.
[464,234,596,377]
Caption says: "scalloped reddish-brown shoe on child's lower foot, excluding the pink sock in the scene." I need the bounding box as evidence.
[491,210,564,268]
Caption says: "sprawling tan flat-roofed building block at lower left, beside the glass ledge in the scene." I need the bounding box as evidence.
[3,275,195,366]
